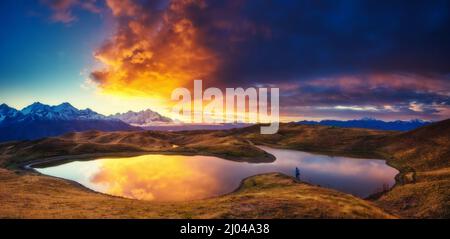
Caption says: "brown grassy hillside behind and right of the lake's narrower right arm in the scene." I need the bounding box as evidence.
[235,120,450,218]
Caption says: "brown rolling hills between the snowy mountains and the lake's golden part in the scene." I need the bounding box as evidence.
[0,131,275,168]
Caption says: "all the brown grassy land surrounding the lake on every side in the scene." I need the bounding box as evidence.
[0,120,450,218]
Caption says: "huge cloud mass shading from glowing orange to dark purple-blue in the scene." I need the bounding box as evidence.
[40,0,450,119]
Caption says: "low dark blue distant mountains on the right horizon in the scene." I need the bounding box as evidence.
[297,118,432,131]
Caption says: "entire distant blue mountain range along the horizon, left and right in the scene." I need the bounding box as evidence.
[0,102,431,142]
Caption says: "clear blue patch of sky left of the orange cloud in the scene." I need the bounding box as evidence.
[0,0,107,111]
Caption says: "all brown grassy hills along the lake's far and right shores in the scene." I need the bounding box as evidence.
[0,120,450,218]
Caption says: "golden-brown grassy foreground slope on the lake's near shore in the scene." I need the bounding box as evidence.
[0,169,393,218]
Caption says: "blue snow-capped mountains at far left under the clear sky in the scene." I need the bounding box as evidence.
[0,102,140,142]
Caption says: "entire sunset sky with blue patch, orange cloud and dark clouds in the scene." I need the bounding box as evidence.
[0,0,450,121]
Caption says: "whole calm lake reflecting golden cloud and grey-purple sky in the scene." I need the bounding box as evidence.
[36,147,398,201]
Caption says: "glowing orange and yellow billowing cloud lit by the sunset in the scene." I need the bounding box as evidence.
[91,0,218,99]
